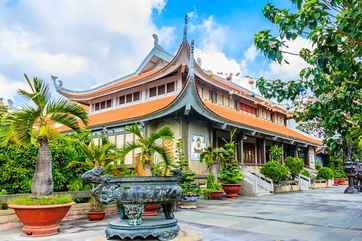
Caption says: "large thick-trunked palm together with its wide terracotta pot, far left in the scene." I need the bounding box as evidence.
[5,75,88,236]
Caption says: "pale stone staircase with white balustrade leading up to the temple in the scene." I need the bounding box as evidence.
[241,167,274,196]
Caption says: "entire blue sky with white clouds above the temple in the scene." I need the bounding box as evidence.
[0,0,308,105]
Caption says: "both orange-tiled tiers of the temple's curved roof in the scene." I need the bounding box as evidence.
[54,18,321,145]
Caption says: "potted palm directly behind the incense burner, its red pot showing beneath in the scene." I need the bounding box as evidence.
[121,124,174,216]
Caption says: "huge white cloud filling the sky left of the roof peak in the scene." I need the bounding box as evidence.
[0,0,175,100]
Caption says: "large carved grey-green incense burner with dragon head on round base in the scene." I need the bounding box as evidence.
[82,167,182,241]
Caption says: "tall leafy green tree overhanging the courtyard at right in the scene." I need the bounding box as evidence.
[255,0,362,160]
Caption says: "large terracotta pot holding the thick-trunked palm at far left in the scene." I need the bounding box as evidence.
[9,203,73,237]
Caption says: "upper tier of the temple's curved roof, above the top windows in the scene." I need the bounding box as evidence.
[52,24,292,114]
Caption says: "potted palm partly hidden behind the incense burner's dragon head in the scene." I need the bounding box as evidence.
[67,136,118,221]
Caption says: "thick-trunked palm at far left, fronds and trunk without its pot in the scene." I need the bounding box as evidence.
[7,75,88,197]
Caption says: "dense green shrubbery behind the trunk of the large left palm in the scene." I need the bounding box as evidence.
[0,133,89,194]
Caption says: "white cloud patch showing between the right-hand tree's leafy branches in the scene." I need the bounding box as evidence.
[265,37,312,80]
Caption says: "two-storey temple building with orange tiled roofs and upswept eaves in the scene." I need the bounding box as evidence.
[54,17,321,174]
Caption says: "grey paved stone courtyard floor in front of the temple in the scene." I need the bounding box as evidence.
[0,187,362,241]
